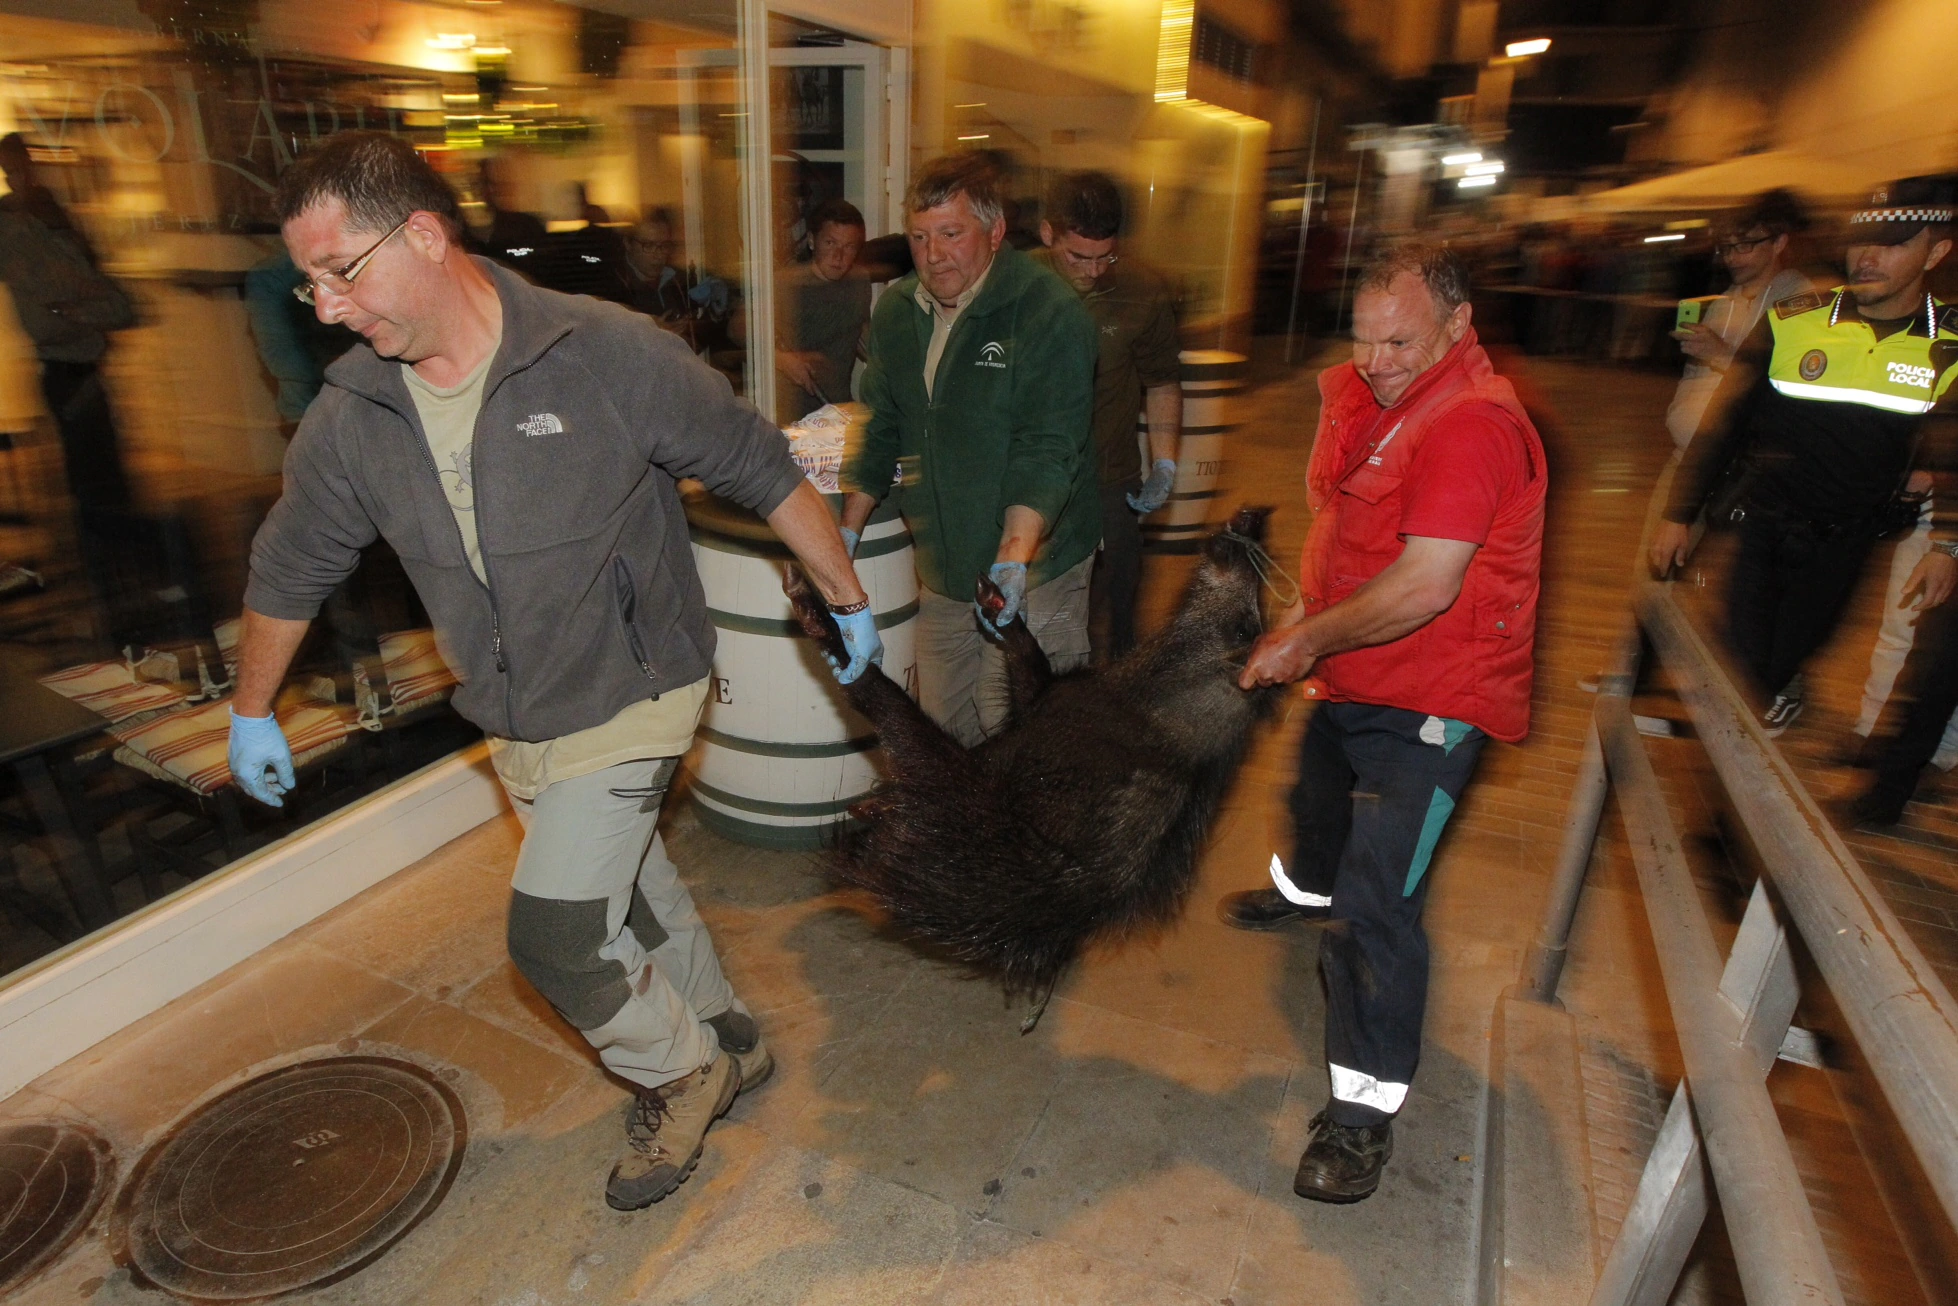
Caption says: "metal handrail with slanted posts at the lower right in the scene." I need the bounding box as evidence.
[1480,583,1958,1306]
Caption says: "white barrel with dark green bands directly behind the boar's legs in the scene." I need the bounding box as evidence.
[687,495,918,848]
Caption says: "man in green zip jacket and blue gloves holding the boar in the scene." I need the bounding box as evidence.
[842,155,1100,746]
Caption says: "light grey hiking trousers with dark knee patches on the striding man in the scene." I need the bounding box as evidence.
[509,758,732,1087]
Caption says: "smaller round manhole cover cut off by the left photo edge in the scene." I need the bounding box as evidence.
[0,1120,112,1292]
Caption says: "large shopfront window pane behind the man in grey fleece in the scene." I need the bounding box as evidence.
[0,0,763,975]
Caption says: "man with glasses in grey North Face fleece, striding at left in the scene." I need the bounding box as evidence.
[231,131,883,1210]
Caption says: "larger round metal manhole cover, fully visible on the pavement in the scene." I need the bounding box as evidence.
[121,1057,468,1302]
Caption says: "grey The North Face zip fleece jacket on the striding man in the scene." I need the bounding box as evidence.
[245,260,803,740]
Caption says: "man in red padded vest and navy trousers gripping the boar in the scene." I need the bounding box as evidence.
[1220,245,1547,1202]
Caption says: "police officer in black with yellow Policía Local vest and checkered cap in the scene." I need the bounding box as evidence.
[1651,176,1958,734]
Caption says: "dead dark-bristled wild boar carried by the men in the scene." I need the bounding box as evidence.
[787,509,1277,993]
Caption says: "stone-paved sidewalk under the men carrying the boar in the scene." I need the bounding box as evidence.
[0,347,1942,1306]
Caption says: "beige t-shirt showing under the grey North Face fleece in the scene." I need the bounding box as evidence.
[401,347,707,803]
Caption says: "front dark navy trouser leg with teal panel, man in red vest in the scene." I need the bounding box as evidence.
[1318,703,1484,1126]
